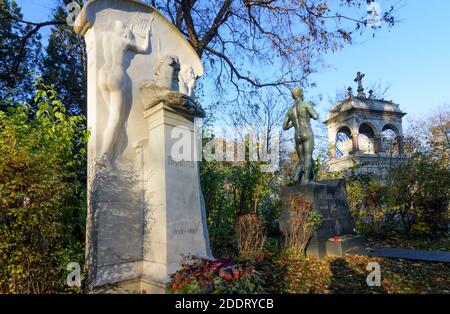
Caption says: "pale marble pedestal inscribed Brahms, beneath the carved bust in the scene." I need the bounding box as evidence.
[143,103,212,290]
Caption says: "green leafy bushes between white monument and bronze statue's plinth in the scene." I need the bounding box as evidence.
[200,136,280,255]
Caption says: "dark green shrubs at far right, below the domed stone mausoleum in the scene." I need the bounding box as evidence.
[346,151,450,238]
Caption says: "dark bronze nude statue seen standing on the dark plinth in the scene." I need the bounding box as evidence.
[283,87,319,184]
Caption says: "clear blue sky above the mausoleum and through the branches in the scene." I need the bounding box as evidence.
[16,0,450,121]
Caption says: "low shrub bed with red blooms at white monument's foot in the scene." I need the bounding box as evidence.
[168,257,264,294]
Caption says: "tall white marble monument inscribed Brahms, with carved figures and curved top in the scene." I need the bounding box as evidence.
[74,0,211,293]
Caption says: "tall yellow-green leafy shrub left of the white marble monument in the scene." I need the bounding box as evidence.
[0,82,87,293]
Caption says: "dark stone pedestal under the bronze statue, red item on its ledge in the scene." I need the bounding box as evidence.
[280,180,365,258]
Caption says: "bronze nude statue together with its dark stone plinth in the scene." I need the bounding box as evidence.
[280,88,364,257]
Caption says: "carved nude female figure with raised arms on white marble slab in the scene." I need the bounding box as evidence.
[97,21,151,168]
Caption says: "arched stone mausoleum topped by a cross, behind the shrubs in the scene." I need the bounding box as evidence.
[324,72,408,180]
